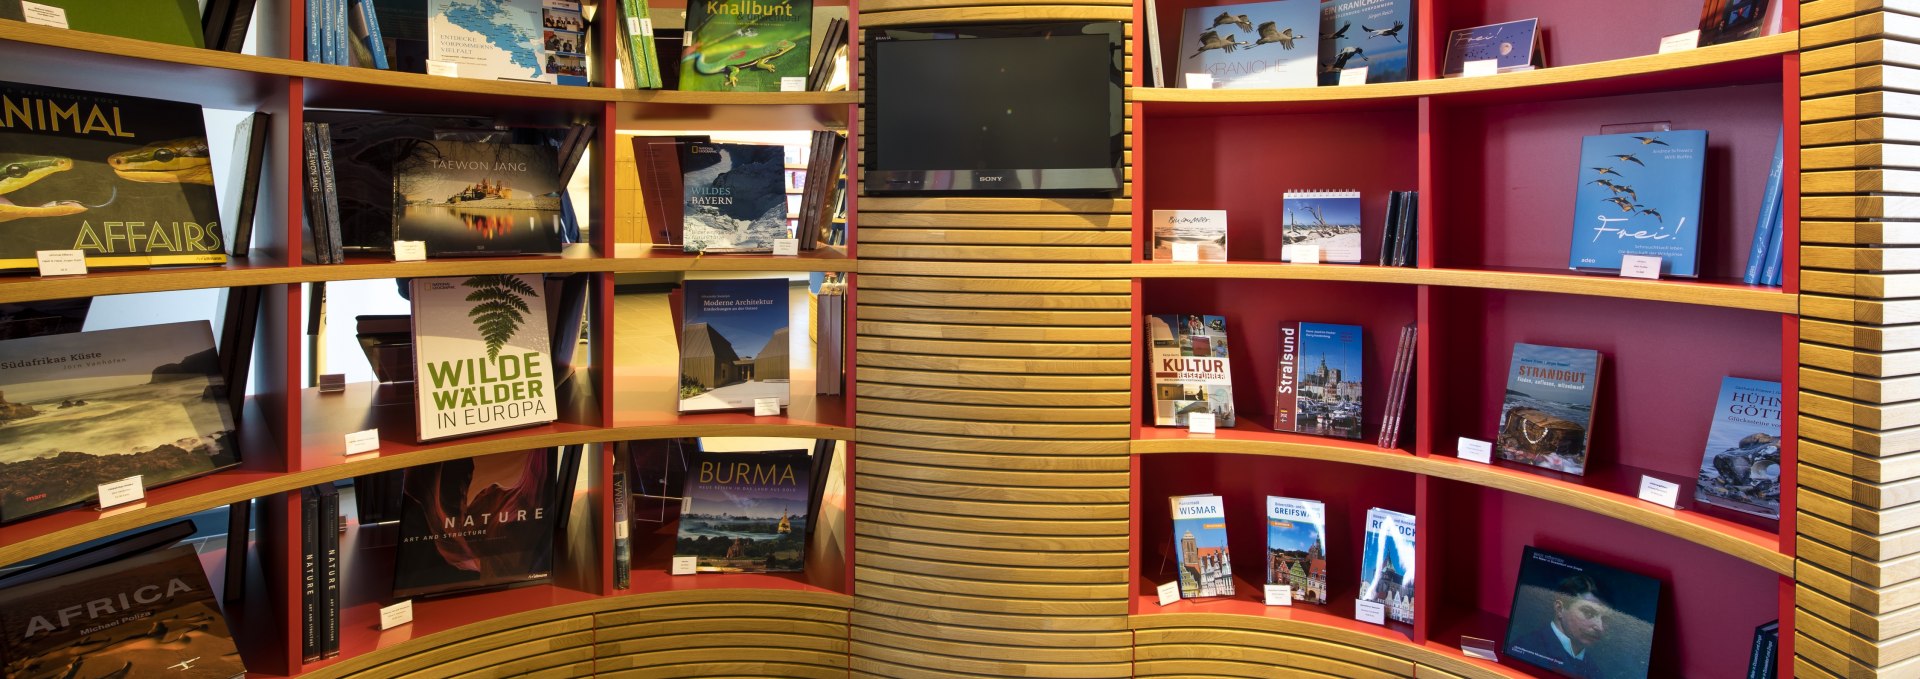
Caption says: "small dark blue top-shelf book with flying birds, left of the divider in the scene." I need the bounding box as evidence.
[1319,0,1417,84]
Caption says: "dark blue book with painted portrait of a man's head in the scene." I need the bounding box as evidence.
[1501,545,1661,679]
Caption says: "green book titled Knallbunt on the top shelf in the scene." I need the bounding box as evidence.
[680,0,814,92]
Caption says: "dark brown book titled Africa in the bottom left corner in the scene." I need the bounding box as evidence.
[0,545,246,679]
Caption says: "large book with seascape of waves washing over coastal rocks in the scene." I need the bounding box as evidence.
[0,320,240,522]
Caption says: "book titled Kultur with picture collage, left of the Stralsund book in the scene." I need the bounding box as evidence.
[1146,315,1235,423]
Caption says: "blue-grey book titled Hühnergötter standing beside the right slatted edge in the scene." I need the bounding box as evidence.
[1693,378,1782,518]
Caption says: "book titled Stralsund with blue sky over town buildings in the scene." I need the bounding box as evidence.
[1273,320,1367,439]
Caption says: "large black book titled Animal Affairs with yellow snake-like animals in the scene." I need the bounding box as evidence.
[0,82,227,270]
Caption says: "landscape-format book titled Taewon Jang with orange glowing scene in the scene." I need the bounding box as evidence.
[394,142,566,257]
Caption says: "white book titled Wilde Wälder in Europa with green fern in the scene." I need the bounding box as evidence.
[413,274,557,441]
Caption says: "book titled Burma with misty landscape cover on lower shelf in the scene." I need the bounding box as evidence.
[674,451,812,574]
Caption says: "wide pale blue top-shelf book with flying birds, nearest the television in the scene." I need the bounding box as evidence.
[1173,0,1321,88]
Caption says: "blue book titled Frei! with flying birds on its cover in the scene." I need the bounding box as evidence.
[1567,130,1707,278]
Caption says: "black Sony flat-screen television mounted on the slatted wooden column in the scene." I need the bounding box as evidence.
[860,21,1125,196]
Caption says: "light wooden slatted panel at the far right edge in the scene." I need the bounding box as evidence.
[1793,0,1920,677]
